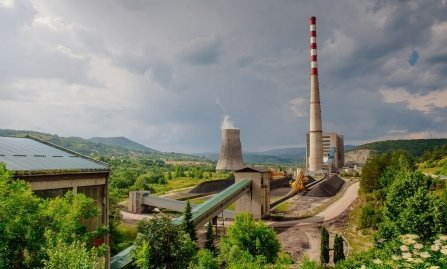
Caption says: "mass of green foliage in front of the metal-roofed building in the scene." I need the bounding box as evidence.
[0,164,107,268]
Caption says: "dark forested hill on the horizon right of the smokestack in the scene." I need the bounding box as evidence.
[353,138,447,157]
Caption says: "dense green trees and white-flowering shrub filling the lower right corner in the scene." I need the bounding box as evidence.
[328,147,447,268]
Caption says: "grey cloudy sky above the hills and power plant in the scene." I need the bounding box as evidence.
[0,0,447,153]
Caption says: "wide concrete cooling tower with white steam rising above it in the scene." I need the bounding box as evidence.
[216,129,245,171]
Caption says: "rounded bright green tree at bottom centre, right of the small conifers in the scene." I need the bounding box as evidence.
[219,213,280,263]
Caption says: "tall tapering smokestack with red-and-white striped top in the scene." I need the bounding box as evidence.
[308,17,323,172]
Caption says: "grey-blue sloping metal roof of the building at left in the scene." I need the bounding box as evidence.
[0,137,109,172]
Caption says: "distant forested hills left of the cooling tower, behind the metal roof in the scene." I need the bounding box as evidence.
[0,129,199,160]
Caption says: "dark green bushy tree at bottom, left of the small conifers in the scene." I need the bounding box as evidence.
[133,216,197,269]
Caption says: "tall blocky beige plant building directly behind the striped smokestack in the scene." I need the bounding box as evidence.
[306,133,345,168]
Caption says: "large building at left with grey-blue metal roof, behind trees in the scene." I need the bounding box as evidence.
[0,137,109,237]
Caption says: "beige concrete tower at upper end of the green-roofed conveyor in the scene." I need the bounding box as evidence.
[235,171,271,219]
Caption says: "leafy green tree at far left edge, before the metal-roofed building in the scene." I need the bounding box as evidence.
[0,163,46,268]
